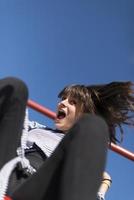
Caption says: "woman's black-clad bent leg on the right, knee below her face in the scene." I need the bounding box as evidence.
[13,115,108,200]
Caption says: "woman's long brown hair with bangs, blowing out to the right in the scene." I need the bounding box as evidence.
[58,81,134,143]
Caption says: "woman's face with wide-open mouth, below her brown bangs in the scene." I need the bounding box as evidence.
[55,98,80,132]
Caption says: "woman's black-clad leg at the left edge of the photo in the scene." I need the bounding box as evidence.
[0,77,28,169]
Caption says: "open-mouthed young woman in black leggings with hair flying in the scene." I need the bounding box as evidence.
[0,78,134,200]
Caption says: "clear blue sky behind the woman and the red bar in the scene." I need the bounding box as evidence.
[0,0,134,200]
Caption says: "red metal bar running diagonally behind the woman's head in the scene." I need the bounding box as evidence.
[27,100,134,161]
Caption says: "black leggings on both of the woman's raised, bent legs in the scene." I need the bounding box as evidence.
[0,79,108,200]
